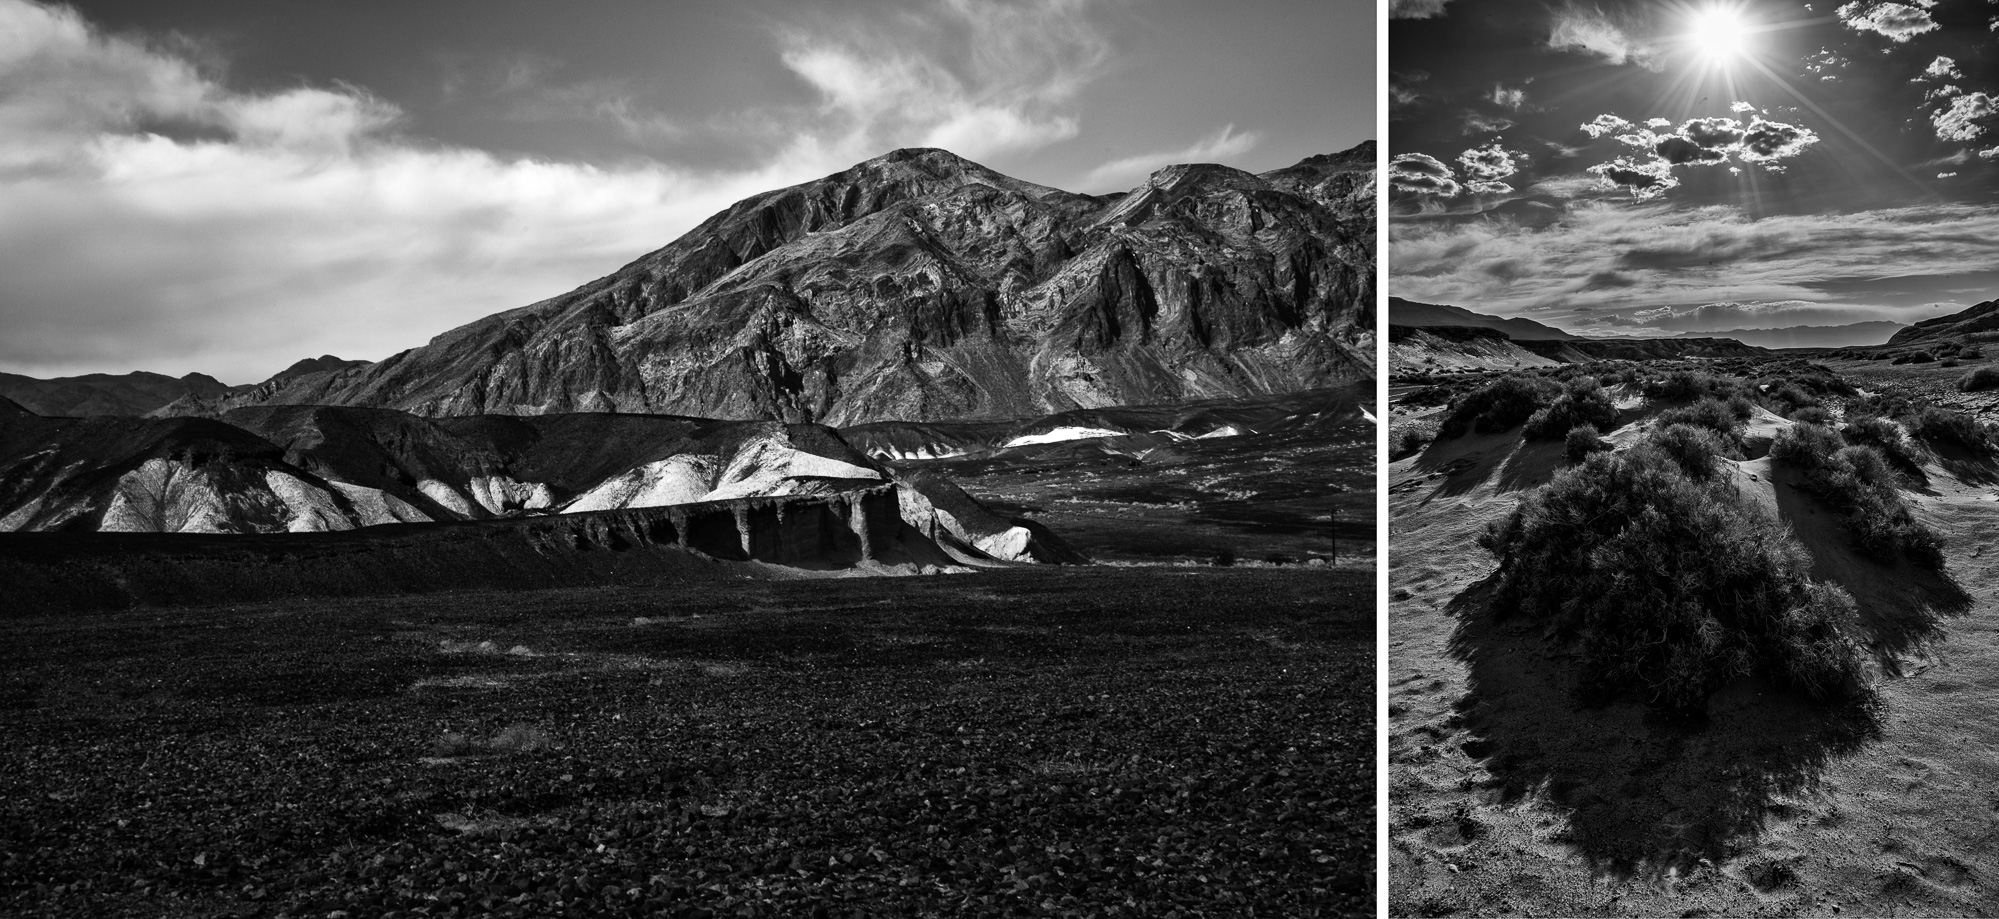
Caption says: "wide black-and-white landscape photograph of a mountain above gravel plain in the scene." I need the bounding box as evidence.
[0,0,1375,919]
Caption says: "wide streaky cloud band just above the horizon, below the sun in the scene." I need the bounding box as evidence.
[1389,200,1999,319]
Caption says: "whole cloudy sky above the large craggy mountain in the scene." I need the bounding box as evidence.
[0,0,1375,384]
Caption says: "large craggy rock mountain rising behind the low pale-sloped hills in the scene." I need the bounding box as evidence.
[175,142,1375,424]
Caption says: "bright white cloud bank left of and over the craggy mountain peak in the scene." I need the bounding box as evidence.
[0,0,1127,382]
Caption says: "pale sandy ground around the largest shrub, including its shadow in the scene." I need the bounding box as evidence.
[1389,393,1999,917]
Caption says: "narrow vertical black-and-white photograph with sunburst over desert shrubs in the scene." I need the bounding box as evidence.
[1381,0,1999,917]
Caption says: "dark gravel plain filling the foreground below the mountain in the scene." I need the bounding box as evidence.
[0,565,1375,917]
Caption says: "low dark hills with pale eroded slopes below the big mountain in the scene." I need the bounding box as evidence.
[0,406,1081,563]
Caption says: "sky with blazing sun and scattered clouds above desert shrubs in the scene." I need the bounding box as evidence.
[1387,0,1999,344]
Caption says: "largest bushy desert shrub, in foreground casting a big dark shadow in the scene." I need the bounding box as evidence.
[1479,441,1873,713]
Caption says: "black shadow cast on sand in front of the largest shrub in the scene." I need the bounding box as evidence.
[1449,575,1879,877]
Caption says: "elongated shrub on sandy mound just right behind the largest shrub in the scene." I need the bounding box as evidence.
[1769,424,1943,567]
